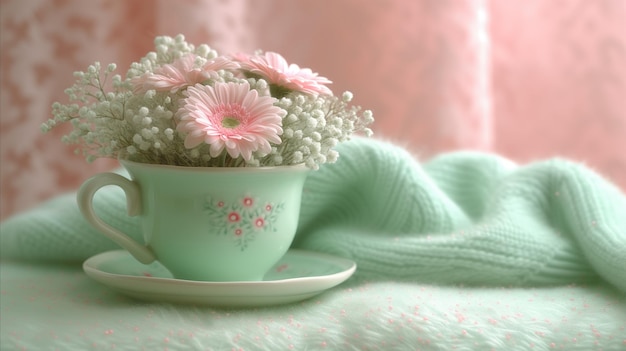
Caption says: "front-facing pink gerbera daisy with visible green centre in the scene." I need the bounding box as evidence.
[176,82,284,161]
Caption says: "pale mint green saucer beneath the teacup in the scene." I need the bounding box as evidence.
[83,250,356,307]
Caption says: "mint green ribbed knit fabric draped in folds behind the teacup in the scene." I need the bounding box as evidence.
[0,138,626,292]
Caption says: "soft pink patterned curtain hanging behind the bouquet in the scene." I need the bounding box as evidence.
[0,0,626,218]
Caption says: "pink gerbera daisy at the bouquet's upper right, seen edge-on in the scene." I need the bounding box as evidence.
[235,52,332,96]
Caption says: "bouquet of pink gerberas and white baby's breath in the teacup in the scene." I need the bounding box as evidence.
[42,35,373,169]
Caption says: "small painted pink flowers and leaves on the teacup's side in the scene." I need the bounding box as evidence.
[204,196,284,251]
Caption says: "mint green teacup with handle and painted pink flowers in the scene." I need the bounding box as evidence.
[78,160,307,281]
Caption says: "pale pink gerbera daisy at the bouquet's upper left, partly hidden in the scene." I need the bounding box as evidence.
[131,54,239,93]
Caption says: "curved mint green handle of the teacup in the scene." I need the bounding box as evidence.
[77,173,156,264]
